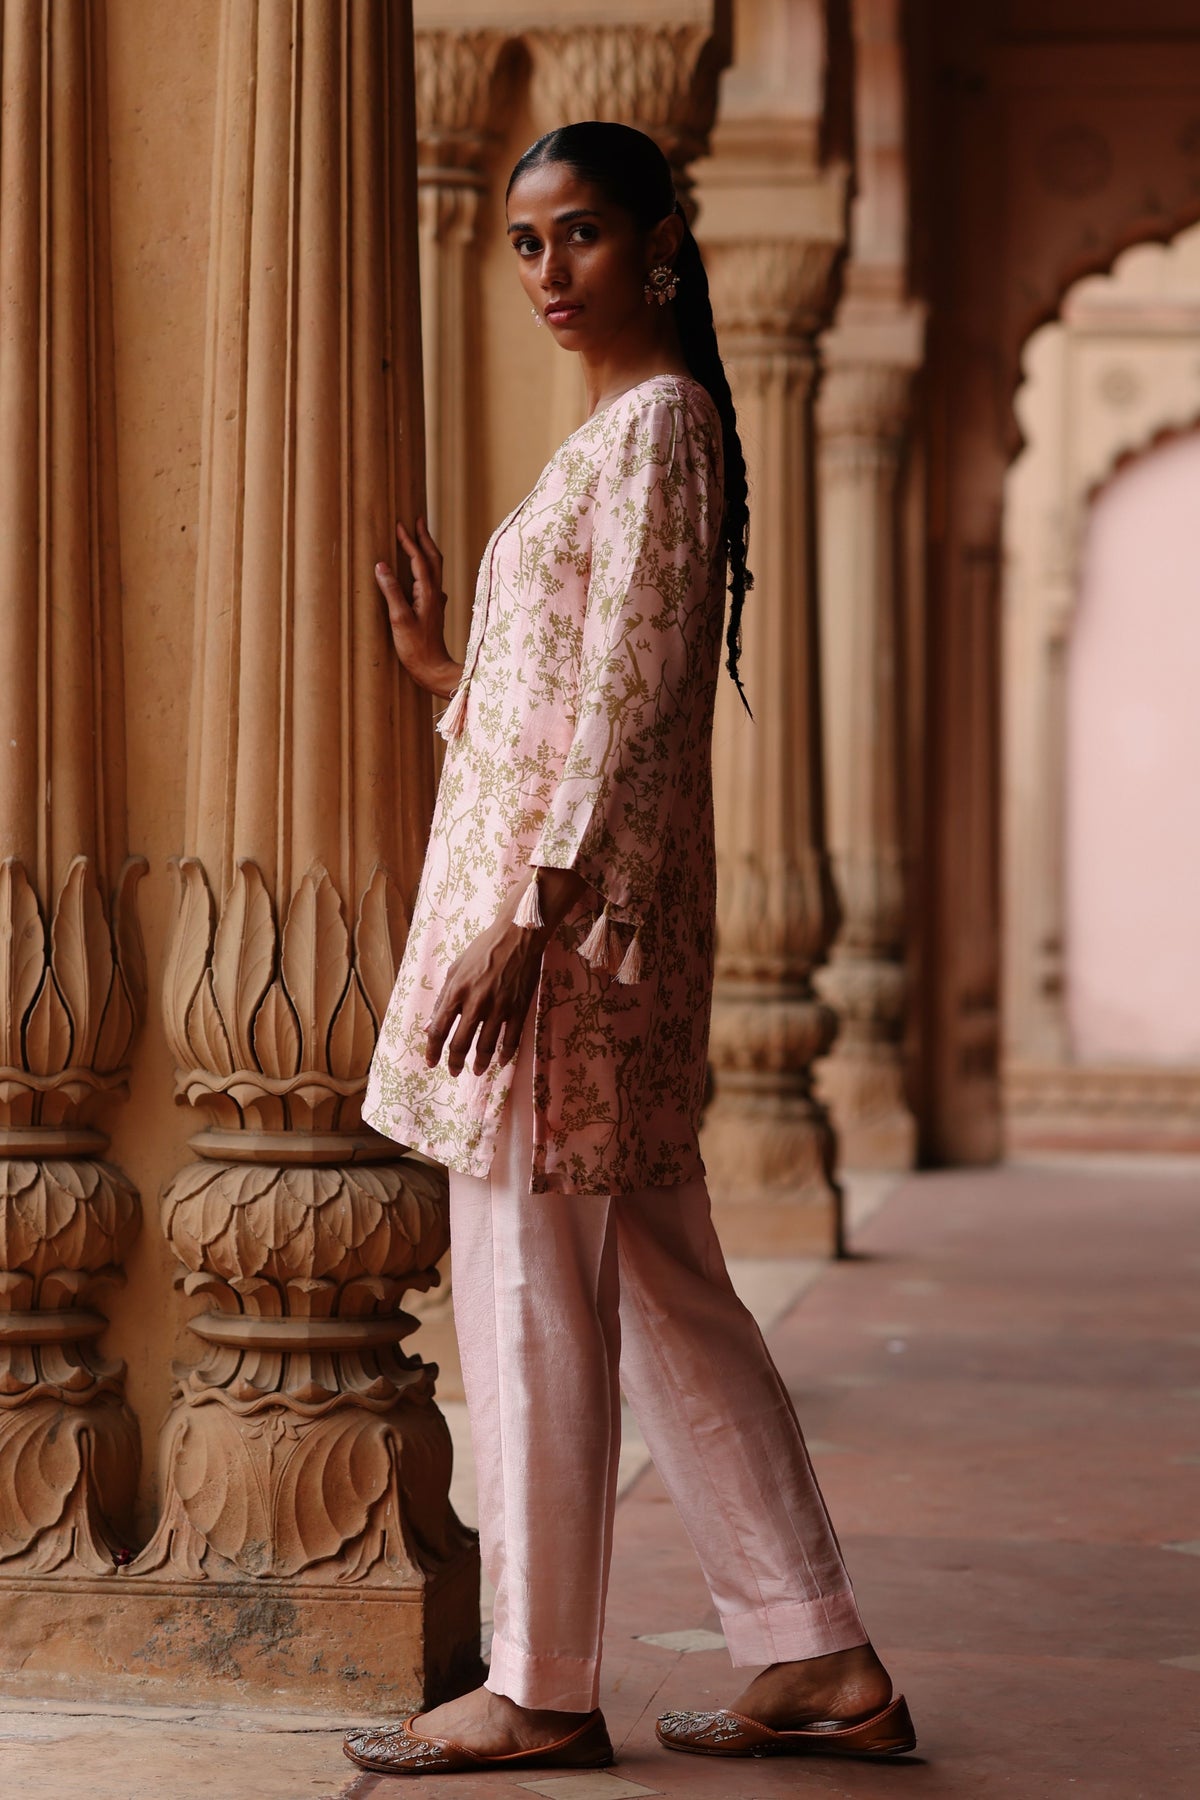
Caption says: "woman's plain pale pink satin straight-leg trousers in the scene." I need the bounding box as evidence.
[450,1031,867,1712]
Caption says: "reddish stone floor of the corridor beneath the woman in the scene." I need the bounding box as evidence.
[0,1163,1200,1800]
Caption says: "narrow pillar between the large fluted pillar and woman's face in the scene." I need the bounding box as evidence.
[416,31,511,655]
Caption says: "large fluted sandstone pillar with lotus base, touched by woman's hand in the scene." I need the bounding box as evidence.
[118,0,479,1710]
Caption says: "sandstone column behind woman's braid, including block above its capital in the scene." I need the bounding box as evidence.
[683,0,851,1255]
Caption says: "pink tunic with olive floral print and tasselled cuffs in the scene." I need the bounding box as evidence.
[363,376,725,1193]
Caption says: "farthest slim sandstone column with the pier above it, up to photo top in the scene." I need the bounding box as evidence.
[819,0,925,1168]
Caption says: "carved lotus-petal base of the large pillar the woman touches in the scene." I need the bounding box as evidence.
[130,859,470,1586]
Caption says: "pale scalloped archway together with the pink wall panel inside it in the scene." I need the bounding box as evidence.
[1004,229,1200,1148]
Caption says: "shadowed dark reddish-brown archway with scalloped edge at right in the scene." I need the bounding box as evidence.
[909,0,1200,1163]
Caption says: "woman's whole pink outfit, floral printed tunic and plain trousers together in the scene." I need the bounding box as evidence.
[363,376,865,1712]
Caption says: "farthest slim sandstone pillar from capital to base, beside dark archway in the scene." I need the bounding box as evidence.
[819,358,916,1168]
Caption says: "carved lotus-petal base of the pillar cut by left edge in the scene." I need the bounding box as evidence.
[0,857,146,1575]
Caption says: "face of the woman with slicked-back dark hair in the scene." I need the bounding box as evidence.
[507,162,655,351]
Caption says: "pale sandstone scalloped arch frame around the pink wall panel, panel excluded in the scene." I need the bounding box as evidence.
[1004,210,1200,1067]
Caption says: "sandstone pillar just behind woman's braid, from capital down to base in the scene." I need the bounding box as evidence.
[702,232,840,1253]
